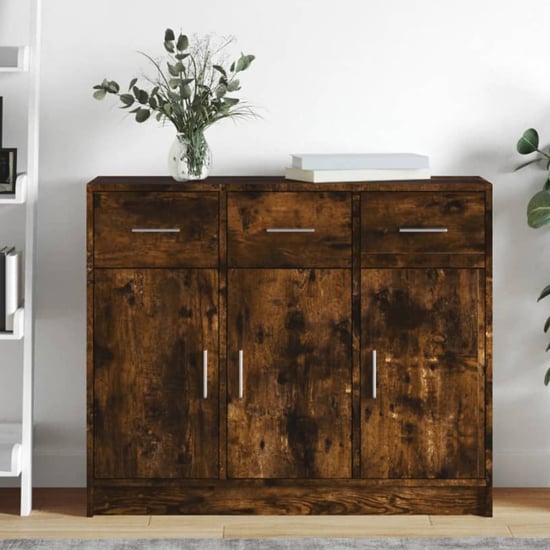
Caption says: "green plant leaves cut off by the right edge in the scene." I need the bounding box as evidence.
[516,128,550,385]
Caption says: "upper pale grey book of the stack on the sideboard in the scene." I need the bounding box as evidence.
[291,153,430,170]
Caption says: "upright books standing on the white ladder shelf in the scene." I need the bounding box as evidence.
[0,246,21,332]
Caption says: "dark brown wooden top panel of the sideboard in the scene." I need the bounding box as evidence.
[88,176,491,192]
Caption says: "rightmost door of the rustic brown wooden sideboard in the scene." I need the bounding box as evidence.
[361,269,485,478]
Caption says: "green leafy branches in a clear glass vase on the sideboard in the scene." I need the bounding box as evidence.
[93,29,254,181]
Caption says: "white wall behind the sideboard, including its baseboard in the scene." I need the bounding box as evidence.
[0,0,550,486]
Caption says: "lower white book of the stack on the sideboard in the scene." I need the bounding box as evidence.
[285,167,431,183]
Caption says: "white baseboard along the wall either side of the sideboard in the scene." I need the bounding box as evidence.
[0,448,550,487]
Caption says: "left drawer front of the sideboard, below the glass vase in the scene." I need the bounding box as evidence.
[94,192,219,267]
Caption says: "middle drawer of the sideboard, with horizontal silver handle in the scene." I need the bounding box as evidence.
[227,191,351,267]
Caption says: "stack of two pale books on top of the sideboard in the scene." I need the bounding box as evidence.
[285,153,431,183]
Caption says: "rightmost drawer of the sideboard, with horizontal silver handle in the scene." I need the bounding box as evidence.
[361,191,485,266]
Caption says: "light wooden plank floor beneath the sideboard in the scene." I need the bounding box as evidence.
[0,489,550,539]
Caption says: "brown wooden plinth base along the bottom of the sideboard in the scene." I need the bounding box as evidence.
[88,486,492,516]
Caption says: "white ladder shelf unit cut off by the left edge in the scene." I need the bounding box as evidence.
[0,0,42,516]
